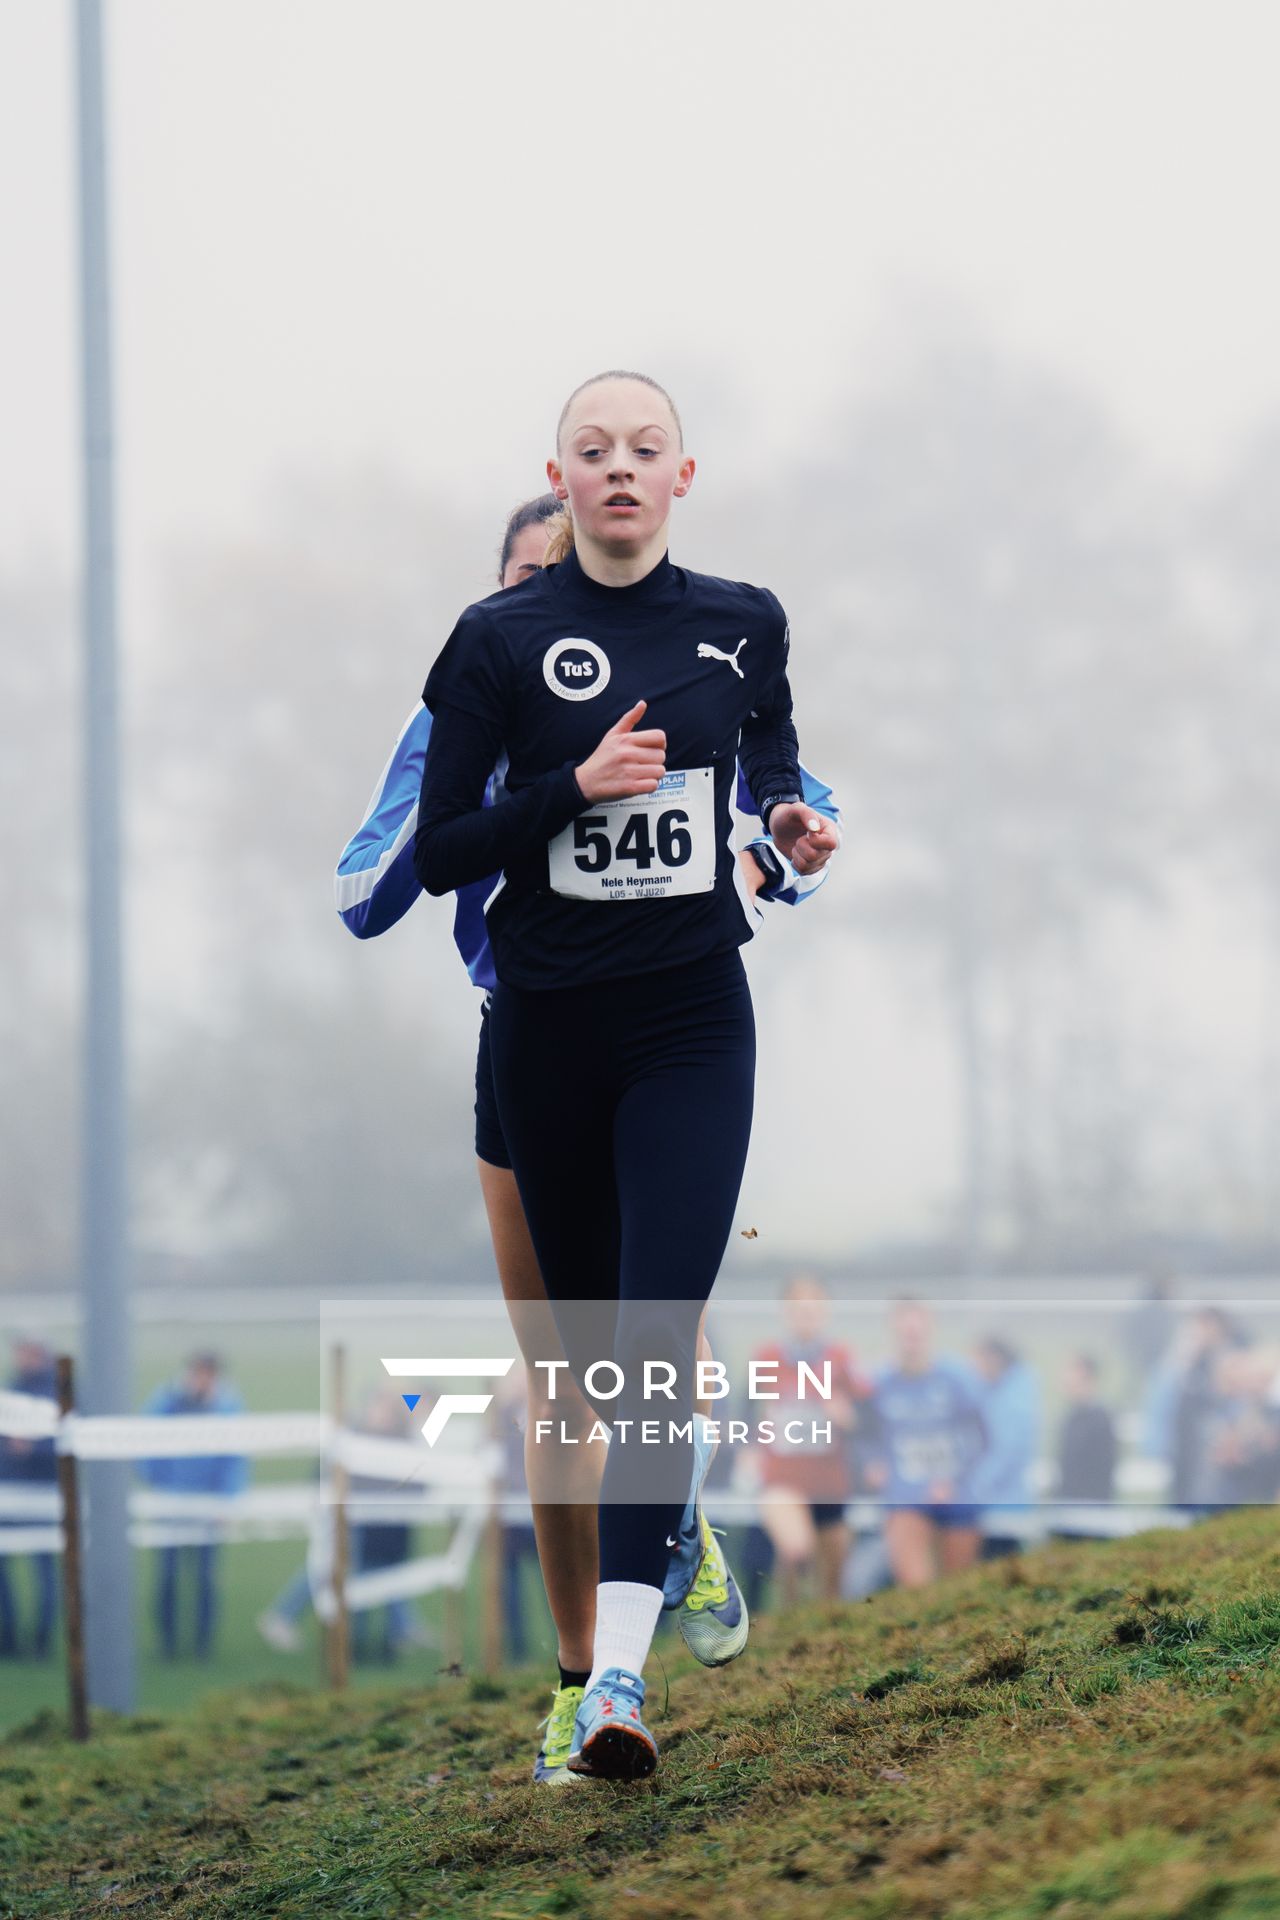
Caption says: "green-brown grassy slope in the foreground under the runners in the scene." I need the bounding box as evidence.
[0,1511,1280,1920]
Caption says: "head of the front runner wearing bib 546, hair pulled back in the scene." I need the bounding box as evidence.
[547,380,693,553]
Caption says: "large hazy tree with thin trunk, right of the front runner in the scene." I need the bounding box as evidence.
[744,340,1178,1269]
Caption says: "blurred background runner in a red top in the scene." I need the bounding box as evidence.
[752,1275,871,1607]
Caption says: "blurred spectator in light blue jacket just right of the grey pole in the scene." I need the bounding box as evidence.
[140,1354,249,1659]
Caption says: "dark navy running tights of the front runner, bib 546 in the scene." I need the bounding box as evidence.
[489,948,756,1586]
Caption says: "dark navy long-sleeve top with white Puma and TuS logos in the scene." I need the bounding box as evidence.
[415,555,800,989]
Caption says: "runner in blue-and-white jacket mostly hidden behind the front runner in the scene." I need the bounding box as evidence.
[336,493,841,1786]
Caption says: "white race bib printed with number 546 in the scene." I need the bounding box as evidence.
[547,766,716,900]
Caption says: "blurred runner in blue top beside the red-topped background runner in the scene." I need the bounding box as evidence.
[867,1300,986,1588]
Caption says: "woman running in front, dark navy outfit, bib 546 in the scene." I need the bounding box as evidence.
[415,372,837,1778]
